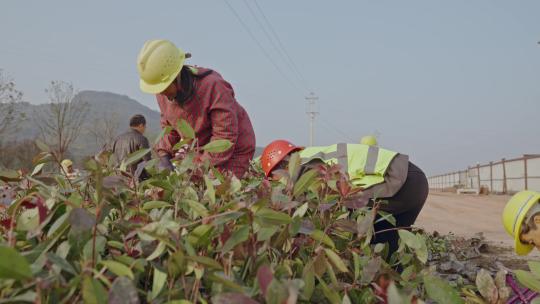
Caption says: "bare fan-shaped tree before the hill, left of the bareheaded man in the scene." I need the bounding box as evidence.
[36,81,89,160]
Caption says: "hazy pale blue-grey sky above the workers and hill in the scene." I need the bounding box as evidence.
[0,0,540,174]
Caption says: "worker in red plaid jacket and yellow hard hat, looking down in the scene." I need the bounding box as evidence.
[137,40,255,177]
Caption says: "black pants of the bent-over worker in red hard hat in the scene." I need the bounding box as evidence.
[373,162,429,257]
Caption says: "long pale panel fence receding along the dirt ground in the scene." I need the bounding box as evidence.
[428,154,540,194]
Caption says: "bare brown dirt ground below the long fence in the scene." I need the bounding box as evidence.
[415,191,540,264]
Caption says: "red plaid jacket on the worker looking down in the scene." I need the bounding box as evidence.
[155,67,255,177]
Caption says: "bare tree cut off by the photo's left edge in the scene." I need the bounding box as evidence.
[0,69,24,140]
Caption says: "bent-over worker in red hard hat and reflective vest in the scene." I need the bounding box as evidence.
[261,140,428,256]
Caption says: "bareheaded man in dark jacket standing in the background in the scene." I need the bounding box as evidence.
[112,114,151,180]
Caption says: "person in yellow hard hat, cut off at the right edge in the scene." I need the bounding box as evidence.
[502,190,540,255]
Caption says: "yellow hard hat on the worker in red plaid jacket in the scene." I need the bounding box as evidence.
[137,40,186,94]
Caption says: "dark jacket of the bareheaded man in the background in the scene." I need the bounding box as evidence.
[112,128,151,174]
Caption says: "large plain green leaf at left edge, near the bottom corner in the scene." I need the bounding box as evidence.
[0,245,32,280]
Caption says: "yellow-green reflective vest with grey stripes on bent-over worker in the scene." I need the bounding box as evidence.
[299,143,399,189]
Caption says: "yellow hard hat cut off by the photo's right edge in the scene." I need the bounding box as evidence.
[502,191,540,255]
